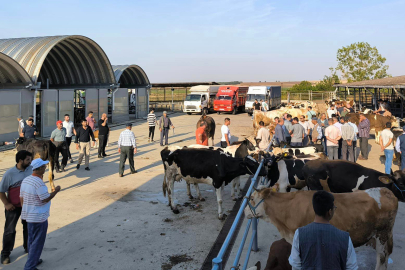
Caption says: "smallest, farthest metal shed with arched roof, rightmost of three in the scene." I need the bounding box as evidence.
[111,65,151,123]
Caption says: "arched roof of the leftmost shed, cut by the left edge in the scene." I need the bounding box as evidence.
[0,53,32,88]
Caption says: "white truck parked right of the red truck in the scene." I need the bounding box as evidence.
[245,86,281,115]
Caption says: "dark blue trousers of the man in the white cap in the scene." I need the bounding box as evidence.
[24,220,48,270]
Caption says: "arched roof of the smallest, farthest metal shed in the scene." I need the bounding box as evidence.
[112,65,150,88]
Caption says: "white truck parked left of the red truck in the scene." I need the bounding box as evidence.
[183,85,220,115]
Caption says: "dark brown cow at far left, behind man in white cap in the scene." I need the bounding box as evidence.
[15,137,56,191]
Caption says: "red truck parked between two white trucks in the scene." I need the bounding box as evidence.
[214,85,249,114]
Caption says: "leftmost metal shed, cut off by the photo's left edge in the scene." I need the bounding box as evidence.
[0,53,34,142]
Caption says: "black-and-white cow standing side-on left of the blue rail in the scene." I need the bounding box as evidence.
[160,147,266,219]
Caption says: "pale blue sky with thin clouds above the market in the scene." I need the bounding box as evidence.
[0,0,405,84]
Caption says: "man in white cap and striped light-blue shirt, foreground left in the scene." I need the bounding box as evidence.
[20,158,60,270]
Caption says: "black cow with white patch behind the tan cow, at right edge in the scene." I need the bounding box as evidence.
[302,160,405,201]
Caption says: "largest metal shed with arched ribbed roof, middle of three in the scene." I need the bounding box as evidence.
[0,35,116,136]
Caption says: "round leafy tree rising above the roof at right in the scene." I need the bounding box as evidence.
[336,42,389,82]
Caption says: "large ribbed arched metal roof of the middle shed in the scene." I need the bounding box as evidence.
[0,35,115,88]
